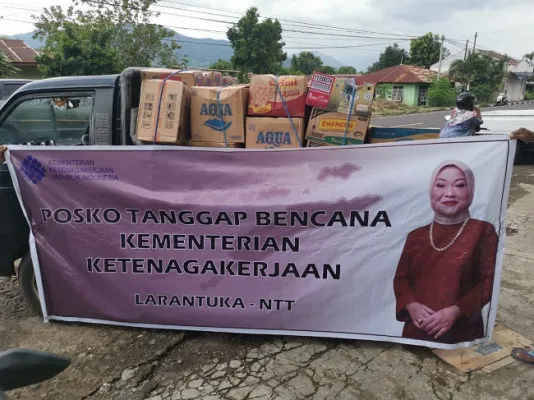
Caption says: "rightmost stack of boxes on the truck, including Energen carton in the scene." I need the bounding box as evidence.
[306,73,375,147]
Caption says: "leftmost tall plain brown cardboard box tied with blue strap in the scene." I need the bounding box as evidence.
[137,79,191,144]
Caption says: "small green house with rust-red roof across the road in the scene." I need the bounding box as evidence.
[356,64,437,106]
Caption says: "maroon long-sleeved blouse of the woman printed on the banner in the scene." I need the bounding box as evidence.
[393,219,499,343]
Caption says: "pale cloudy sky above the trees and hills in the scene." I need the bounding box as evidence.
[0,0,534,70]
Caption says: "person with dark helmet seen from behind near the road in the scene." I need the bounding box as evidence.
[439,92,483,139]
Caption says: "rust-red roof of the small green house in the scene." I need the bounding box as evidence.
[357,64,437,84]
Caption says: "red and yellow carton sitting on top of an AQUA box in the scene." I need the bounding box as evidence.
[248,75,308,118]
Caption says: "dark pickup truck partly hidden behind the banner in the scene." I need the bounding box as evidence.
[0,68,146,315]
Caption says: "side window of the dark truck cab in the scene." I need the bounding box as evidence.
[0,96,93,145]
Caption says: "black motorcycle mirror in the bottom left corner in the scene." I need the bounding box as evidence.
[0,349,71,400]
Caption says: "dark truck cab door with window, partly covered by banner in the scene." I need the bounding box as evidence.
[0,92,94,276]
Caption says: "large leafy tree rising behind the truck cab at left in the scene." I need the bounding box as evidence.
[34,0,179,76]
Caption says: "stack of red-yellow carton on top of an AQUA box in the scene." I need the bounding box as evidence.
[246,75,308,149]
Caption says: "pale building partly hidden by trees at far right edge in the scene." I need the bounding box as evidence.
[430,49,534,101]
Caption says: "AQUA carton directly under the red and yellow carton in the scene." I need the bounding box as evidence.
[246,117,304,149]
